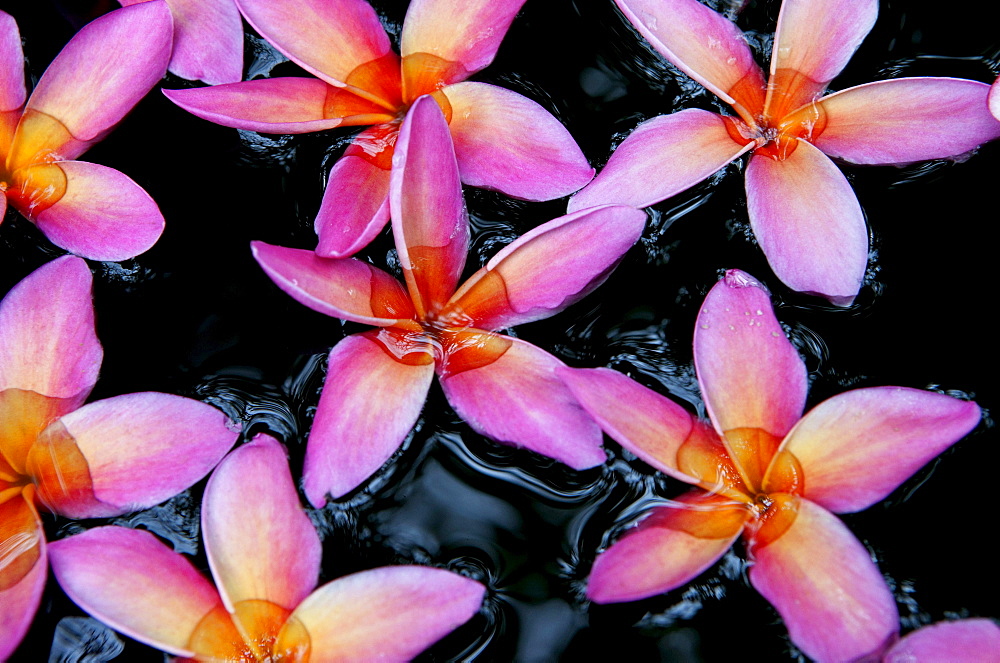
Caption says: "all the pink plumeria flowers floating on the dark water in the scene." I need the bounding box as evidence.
[0,0,1000,661]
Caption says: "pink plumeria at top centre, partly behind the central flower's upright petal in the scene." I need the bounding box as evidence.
[165,0,594,258]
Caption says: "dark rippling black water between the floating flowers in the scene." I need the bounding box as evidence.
[0,0,1000,661]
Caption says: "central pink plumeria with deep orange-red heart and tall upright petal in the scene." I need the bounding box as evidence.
[253,96,645,506]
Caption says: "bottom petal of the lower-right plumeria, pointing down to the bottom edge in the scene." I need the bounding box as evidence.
[750,495,899,661]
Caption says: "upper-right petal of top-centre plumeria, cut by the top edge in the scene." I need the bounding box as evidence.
[400,0,524,84]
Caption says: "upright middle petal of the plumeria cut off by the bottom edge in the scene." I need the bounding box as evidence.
[201,435,322,612]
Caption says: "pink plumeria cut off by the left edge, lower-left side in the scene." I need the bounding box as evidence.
[0,256,236,660]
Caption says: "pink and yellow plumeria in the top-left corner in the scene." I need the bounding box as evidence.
[0,0,172,260]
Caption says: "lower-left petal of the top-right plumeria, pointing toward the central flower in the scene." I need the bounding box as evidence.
[569,108,753,211]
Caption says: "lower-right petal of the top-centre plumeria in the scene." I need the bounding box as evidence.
[442,83,594,200]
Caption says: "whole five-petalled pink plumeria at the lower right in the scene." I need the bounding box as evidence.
[560,271,980,661]
